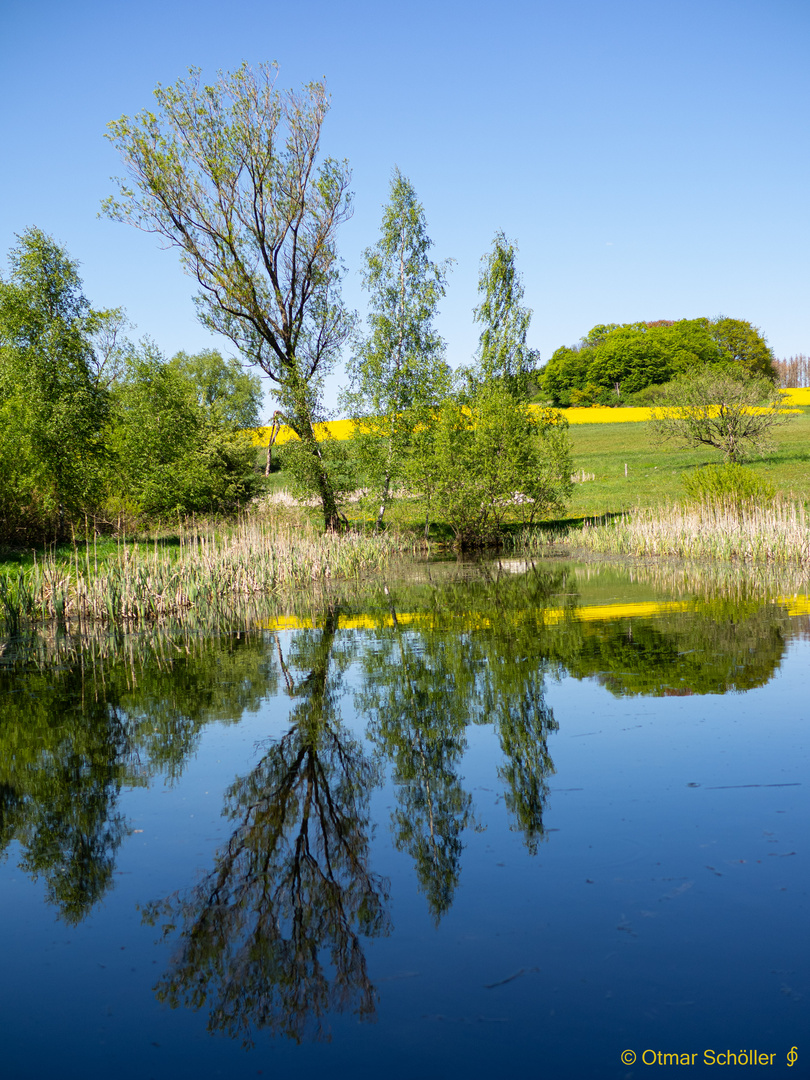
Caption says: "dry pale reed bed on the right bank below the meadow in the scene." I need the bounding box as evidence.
[577,500,810,565]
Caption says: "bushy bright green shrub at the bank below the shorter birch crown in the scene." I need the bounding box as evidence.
[426,384,571,546]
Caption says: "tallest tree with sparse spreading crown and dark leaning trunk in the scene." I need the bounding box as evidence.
[103,64,352,529]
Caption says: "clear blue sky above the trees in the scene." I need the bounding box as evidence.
[0,0,810,414]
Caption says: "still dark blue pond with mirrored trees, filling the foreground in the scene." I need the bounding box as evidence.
[0,564,810,1080]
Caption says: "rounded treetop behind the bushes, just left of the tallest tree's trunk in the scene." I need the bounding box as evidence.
[170,349,261,430]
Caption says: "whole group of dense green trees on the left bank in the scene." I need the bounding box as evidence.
[0,228,260,541]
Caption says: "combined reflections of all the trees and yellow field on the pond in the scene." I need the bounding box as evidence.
[0,564,796,1042]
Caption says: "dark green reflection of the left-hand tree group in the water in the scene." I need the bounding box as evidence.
[0,632,276,923]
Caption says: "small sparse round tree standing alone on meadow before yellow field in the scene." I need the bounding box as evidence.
[650,365,794,462]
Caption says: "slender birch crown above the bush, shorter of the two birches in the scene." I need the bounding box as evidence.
[472,232,538,397]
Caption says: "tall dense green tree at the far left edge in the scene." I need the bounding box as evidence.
[0,228,108,537]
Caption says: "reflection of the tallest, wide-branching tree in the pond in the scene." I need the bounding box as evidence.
[145,608,389,1044]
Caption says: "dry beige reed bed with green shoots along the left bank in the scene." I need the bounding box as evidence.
[0,518,414,634]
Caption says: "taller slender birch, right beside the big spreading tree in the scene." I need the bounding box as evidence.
[347,168,451,528]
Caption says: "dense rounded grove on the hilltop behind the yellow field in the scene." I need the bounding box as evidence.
[540,316,775,406]
